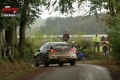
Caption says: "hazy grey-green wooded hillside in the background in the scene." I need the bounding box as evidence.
[40,15,107,35]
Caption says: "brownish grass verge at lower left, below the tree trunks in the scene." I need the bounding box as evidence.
[0,60,31,80]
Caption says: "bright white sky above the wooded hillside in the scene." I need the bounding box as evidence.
[40,1,107,19]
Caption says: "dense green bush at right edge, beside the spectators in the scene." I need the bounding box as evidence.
[106,15,120,61]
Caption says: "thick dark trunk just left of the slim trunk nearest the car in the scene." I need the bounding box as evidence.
[5,27,14,61]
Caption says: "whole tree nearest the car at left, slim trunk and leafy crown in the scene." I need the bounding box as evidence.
[19,0,46,58]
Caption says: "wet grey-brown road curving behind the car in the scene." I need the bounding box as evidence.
[31,64,112,80]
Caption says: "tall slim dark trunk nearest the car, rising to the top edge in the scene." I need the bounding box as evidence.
[19,0,29,58]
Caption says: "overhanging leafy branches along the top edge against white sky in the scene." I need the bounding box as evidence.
[46,0,119,16]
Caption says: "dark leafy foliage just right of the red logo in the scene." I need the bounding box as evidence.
[19,0,46,26]
